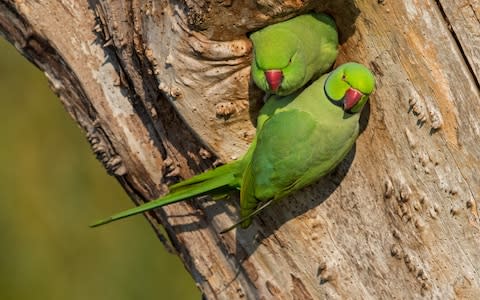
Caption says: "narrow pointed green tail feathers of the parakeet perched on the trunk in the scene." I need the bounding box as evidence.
[90,169,236,227]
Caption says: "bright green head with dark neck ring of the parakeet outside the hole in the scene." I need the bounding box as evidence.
[325,62,375,113]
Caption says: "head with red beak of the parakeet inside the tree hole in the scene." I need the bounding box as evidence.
[250,27,306,96]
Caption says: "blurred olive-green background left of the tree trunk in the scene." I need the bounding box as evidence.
[0,38,200,300]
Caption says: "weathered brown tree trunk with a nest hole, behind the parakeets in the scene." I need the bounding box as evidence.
[0,0,480,299]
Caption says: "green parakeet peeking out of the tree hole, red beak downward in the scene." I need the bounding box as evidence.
[250,13,338,96]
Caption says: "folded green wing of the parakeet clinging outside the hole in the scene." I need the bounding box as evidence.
[240,110,317,228]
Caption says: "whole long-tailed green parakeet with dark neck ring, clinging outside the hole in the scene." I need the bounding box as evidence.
[91,63,375,230]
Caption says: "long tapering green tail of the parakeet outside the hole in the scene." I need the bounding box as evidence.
[90,161,240,227]
